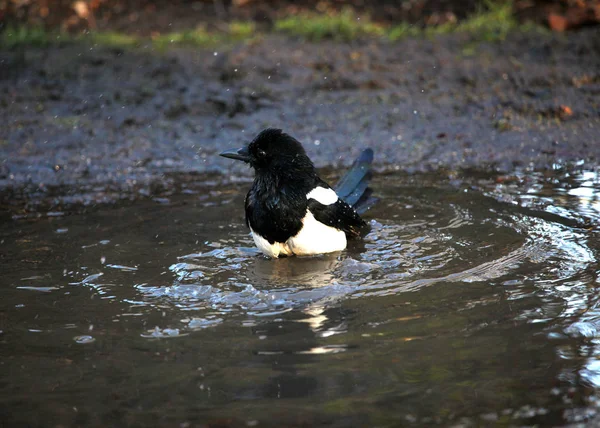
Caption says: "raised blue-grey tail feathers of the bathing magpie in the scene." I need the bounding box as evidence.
[335,149,378,214]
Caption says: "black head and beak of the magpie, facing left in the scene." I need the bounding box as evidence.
[220,128,314,173]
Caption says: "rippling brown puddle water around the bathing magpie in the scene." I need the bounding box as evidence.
[0,171,600,426]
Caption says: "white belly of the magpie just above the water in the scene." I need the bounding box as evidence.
[250,211,346,258]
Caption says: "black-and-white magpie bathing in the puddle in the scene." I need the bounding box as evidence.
[220,128,374,258]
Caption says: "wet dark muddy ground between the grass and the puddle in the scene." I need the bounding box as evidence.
[0,28,600,210]
